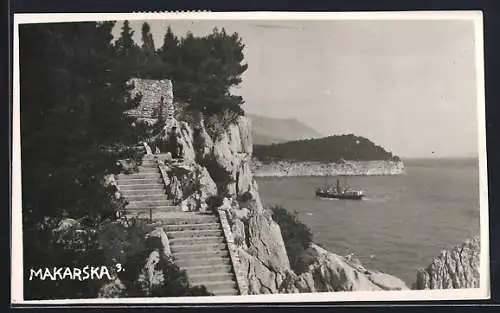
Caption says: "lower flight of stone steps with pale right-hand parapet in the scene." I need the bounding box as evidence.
[161,212,239,296]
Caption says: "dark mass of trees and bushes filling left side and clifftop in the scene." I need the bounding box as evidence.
[19,22,246,299]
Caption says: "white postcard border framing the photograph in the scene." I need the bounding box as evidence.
[11,11,490,305]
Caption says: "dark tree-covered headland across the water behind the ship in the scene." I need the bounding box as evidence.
[254,134,399,162]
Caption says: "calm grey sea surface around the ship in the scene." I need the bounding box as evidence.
[257,159,479,286]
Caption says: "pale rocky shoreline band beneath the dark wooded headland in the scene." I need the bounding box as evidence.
[252,159,405,177]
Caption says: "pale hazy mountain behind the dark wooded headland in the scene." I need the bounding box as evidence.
[247,114,322,145]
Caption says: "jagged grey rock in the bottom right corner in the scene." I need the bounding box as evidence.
[415,237,480,289]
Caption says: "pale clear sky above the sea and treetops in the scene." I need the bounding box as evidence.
[113,20,478,158]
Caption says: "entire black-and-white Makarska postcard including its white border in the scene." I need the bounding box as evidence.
[12,11,490,304]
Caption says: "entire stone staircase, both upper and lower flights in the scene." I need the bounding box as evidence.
[117,154,240,296]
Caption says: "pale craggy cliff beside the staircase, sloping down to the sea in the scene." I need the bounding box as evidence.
[136,98,407,294]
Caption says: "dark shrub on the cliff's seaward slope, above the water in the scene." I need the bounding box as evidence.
[271,206,313,274]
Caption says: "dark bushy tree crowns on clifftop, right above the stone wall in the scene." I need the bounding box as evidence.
[158,27,248,115]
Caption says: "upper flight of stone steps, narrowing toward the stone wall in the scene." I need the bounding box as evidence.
[117,155,181,216]
